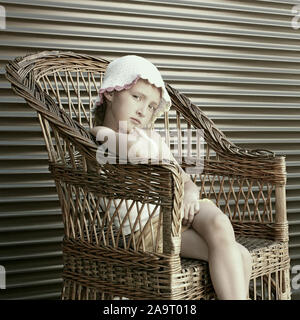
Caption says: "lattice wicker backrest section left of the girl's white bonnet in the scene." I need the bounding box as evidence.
[34,53,109,127]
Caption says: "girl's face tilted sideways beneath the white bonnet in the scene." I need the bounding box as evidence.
[103,79,161,133]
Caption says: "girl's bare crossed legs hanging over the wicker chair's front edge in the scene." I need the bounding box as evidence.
[181,203,251,300]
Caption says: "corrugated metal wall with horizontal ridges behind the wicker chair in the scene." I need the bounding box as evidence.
[0,0,300,299]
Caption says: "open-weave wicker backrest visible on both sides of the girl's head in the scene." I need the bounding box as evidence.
[16,51,205,171]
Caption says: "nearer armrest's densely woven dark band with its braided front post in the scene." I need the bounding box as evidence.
[49,155,184,255]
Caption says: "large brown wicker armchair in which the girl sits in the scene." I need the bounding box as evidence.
[6,51,290,300]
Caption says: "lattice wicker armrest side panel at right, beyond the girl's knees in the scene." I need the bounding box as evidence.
[180,156,288,242]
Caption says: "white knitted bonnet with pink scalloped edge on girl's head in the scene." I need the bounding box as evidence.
[95,55,171,127]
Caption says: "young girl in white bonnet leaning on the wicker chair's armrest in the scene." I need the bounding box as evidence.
[91,56,252,300]
